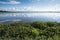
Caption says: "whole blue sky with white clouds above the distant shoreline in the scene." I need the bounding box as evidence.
[0,0,60,11]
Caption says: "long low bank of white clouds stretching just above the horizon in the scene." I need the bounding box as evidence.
[2,4,60,11]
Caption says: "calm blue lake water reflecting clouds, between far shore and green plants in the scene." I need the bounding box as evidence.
[0,13,60,22]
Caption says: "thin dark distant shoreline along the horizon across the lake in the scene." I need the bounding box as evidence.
[0,11,60,13]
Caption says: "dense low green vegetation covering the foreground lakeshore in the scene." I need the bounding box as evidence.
[0,22,60,40]
